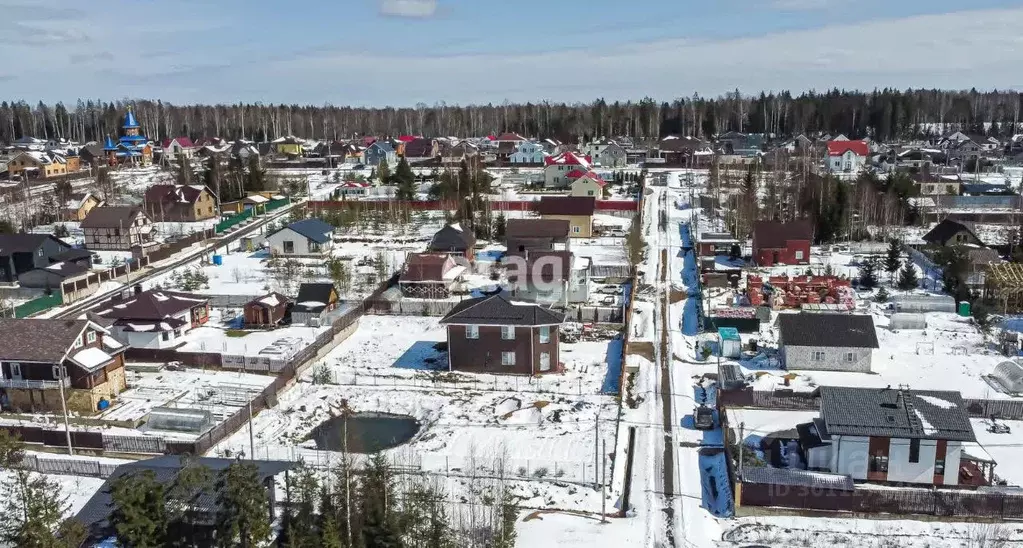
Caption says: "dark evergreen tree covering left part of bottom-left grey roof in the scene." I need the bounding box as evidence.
[110,470,167,548]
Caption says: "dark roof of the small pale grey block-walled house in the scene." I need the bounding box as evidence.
[777,313,878,349]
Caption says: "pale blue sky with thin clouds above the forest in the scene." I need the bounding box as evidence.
[6,0,1023,106]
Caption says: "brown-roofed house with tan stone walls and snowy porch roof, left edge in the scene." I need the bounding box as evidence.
[0,318,127,414]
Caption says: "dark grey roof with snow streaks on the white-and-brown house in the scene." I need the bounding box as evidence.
[820,386,976,442]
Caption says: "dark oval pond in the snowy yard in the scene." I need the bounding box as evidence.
[310,413,419,453]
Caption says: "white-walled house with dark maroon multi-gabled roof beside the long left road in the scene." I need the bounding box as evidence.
[95,289,210,349]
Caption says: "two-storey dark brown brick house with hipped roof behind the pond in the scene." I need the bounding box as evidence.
[440,293,565,375]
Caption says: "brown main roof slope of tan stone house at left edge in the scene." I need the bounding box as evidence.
[0,318,89,363]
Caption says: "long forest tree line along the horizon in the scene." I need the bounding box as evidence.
[0,89,1023,143]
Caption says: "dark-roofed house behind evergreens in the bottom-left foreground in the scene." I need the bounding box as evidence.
[75,455,297,547]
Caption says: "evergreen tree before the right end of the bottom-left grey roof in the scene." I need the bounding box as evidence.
[216,461,270,548]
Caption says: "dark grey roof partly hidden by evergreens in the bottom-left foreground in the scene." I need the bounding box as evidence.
[76,455,296,537]
